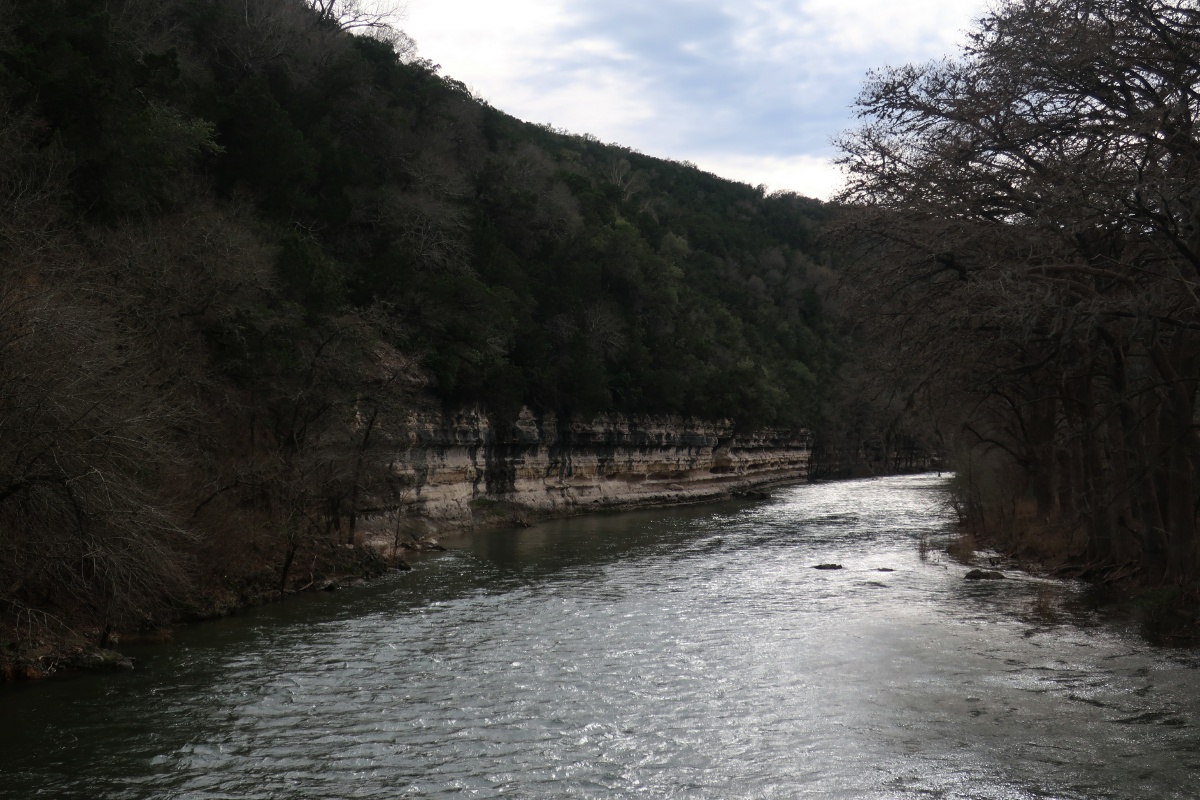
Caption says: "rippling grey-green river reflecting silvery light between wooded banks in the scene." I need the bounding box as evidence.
[0,475,1200,800]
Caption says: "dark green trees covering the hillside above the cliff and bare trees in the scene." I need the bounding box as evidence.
[4,0,828,426]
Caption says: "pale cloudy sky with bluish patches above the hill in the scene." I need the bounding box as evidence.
[401,0,985,198]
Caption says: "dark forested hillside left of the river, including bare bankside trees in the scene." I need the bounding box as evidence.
[0,0,835,662]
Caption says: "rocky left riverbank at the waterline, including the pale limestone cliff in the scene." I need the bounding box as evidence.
[0,409,811,682]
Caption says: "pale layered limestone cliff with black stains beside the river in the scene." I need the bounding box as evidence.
[379,409,810,527]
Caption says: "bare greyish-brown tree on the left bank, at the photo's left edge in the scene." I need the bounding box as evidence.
[0,108,190,643]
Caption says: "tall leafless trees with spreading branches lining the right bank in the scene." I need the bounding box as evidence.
[841,0,1200,583]
